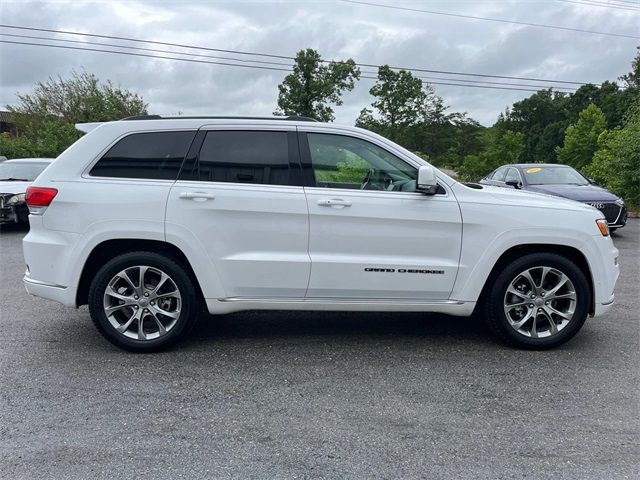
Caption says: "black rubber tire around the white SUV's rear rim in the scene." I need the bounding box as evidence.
[88,251,201,353]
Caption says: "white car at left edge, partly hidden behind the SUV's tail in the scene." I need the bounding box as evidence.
[0,158,53,224]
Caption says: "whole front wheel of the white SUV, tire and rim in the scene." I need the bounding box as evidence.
[485,253,591,350]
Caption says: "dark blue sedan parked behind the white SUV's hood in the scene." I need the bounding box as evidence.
[480,163,627,232]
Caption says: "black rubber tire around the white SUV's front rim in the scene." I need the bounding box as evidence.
[484,253,591,350]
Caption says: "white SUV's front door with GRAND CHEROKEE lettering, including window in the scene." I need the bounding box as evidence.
[299,126,462,300]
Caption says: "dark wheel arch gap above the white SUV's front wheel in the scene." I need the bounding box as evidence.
[476,243,595,315]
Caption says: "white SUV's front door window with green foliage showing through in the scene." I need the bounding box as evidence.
[307,133,418,192]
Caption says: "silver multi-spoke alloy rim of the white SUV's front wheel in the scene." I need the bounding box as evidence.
[504,266,577,338]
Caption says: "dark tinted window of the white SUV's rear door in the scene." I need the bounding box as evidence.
[190,130,290,185]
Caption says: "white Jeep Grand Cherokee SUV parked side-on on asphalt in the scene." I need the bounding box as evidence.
[24,116,618,351]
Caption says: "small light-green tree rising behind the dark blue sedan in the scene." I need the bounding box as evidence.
[556,103,607,169]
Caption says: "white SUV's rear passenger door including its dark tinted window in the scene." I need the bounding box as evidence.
[166,125,310,299]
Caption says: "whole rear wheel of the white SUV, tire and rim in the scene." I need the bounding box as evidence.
[88,252,198,352]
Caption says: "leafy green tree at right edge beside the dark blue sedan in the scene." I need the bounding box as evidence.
[585,94,640,211]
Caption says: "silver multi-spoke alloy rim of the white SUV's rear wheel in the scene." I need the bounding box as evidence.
[103,265,182,341]
